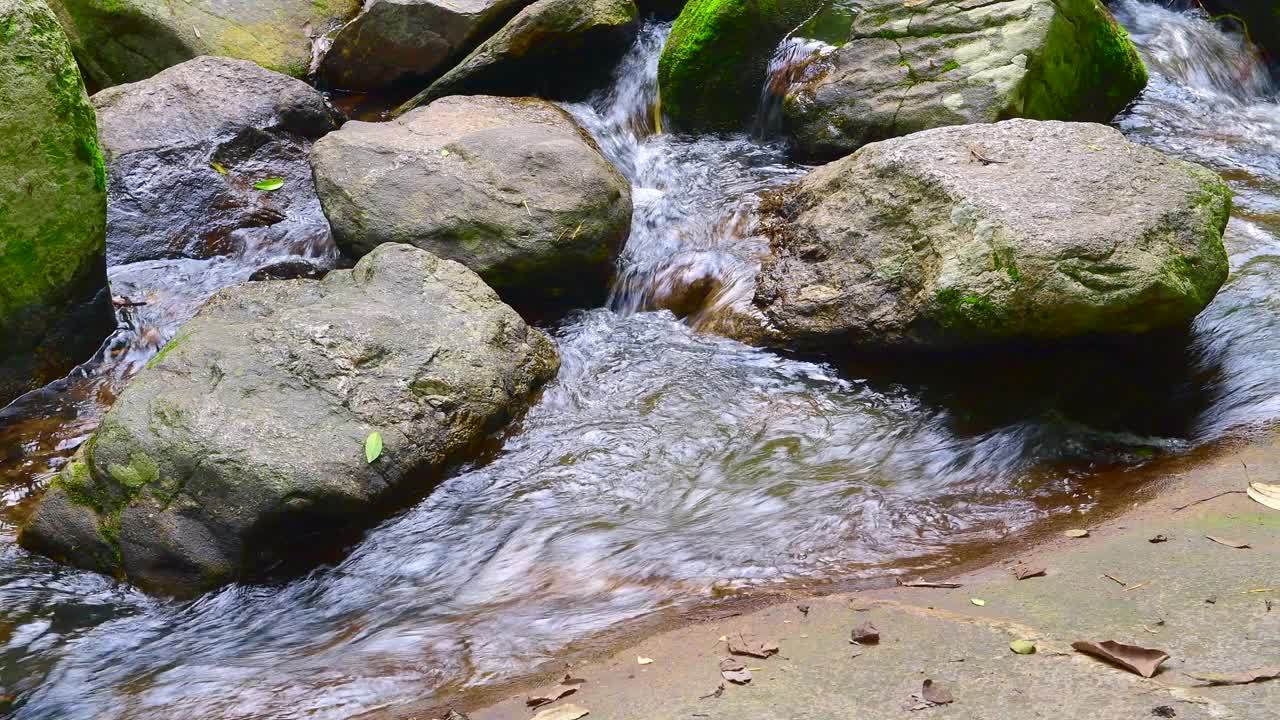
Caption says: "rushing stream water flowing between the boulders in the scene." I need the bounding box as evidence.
[0,0,1280,720]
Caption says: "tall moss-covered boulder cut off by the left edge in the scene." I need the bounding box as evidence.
[0,0,115,406]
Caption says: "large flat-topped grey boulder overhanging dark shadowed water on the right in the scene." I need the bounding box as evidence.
[756,120,1231,350]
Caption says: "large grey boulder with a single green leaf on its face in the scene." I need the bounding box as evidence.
[19,245,559,594]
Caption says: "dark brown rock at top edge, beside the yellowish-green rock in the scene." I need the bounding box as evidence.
[316,0,542,91]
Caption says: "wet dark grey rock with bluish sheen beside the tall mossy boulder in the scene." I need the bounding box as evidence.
[93,58,342,264]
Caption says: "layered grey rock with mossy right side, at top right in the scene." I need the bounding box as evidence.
[782,0,1147,158]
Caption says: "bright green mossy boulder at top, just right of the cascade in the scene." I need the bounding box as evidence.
[658,0,826,132]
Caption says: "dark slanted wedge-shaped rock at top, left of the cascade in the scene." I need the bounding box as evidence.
[401,0,639,111]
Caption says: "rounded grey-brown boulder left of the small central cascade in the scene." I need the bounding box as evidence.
[311,95,631,304]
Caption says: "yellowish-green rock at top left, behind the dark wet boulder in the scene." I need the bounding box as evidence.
[50,0,360,87]
